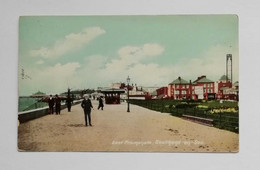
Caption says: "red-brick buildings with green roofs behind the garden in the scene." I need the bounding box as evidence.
[155,75,239,100]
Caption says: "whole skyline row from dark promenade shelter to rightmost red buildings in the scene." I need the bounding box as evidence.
[93,75,239,104]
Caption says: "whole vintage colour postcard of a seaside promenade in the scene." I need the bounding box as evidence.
[17,15,239,153]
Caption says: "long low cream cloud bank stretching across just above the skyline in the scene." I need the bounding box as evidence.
[19,44,238,93]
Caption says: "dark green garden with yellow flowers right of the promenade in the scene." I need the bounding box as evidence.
[129,100,239,133]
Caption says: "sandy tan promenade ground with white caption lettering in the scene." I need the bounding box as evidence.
[18,101,239,152]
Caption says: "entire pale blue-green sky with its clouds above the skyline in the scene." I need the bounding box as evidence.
[19,15,238,95]
